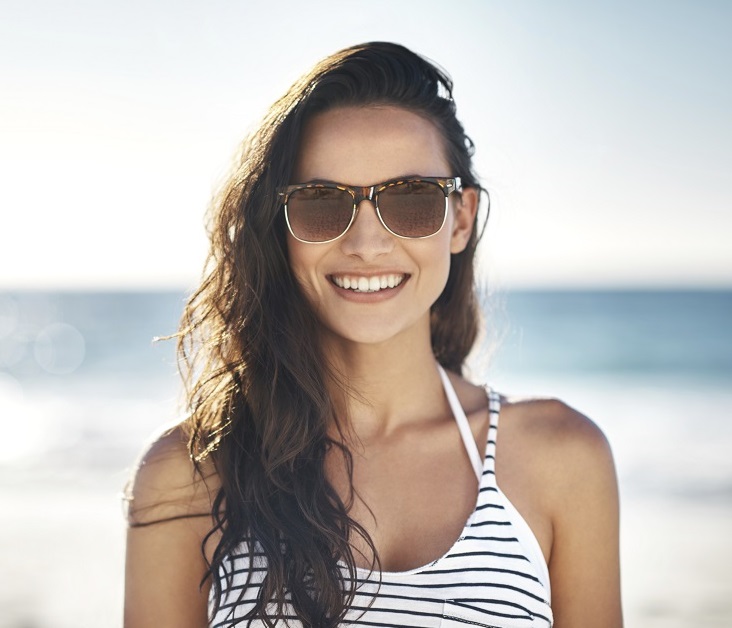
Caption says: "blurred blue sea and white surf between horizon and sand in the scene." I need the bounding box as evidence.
[0,290,732,500]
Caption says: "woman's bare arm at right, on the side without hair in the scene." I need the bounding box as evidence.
[545,402,623,628]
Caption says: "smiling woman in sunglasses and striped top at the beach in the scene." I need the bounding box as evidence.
[125,43,622,628]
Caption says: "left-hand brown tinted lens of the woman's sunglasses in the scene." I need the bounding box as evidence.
[287,187,353,242]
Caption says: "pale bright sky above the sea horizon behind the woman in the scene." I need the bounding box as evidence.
[0,0,732,290]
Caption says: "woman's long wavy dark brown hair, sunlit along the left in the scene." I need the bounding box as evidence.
[179,42,481,627]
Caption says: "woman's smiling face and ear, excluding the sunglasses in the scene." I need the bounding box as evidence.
[287,106,477,343]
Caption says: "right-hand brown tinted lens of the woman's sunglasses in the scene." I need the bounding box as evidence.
[379,181,446,238]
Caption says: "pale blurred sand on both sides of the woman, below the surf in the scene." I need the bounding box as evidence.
[0,472,732,628]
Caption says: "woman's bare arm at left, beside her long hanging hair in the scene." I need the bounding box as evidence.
[124,428,218,628]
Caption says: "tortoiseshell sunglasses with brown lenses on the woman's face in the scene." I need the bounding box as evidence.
[278,177,463,244]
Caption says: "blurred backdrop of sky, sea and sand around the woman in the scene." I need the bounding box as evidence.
[0,0,732,628]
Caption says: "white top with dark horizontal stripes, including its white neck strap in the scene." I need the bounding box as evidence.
[210,366,552,628]
